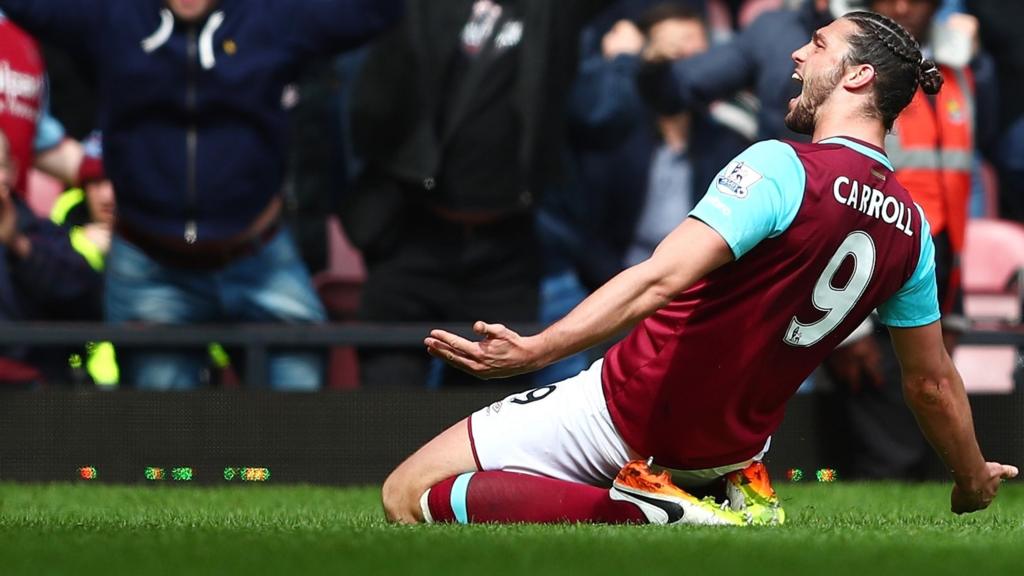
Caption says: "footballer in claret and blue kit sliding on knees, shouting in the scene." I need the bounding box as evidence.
[383,11,1017,526]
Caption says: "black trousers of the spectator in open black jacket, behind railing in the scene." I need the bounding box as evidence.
[358,210,541,388]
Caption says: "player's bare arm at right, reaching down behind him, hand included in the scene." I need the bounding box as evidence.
[889,322,1018,513]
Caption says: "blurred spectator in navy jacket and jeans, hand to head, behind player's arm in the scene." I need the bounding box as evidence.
[535,0,755,385]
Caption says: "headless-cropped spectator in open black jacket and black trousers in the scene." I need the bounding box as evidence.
[342,0,610,386]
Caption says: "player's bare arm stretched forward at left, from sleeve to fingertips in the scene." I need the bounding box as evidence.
[424,218,733,378]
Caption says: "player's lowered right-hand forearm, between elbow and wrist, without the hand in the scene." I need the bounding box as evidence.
[903,361,985,488]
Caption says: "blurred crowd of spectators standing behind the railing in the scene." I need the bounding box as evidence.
[0,0,1024,438]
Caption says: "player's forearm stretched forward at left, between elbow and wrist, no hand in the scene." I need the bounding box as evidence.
[534,262,677,365]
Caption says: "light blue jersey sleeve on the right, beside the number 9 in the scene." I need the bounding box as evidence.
[879,206,942,328]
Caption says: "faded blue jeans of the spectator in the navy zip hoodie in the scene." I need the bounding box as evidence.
[104,226,327,390]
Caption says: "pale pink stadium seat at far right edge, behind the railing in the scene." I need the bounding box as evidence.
[953,218,1024,394]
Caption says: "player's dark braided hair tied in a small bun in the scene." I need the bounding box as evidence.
[843,11,942,130]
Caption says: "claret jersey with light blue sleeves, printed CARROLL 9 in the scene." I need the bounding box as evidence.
[602,137,939,469]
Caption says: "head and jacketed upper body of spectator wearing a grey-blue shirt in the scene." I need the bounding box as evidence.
[570,2,751,289]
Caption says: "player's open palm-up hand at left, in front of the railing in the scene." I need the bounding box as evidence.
[423,322,541,379]
